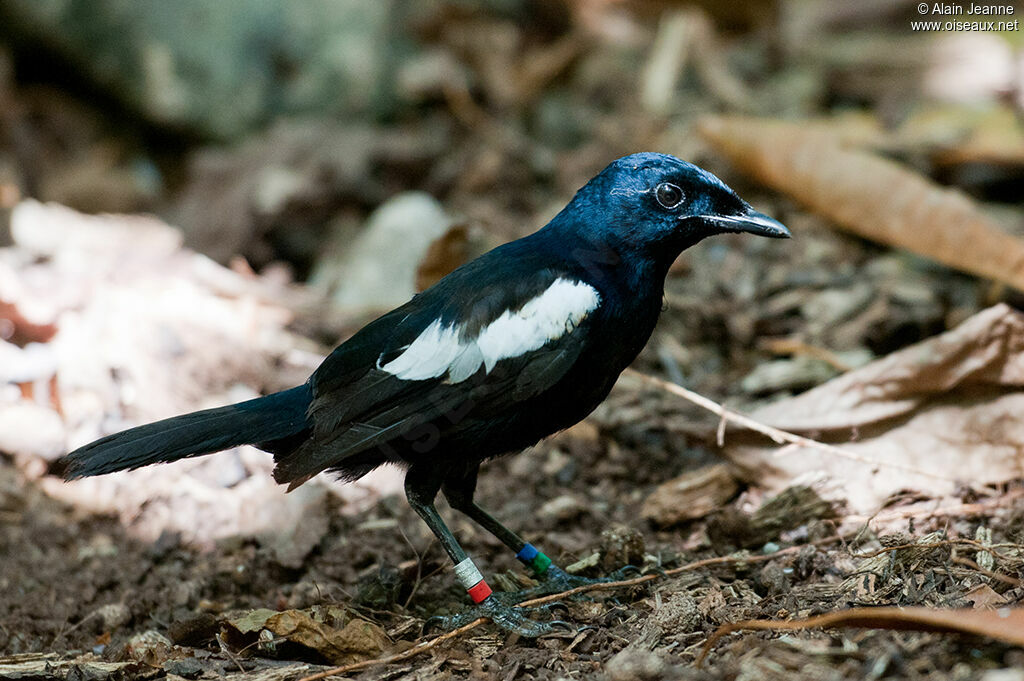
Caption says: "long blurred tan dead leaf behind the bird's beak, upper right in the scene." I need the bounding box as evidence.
[699,117,1024,291]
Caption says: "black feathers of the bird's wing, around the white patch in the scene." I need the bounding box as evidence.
[274,243,584,486]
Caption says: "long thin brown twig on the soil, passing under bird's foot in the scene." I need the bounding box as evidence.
[298,535,842,681]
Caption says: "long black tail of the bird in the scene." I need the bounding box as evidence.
[63,383,312,480]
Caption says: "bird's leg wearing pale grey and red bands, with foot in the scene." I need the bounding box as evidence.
[406,465,568,638]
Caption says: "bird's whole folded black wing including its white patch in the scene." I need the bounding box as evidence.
[274,258,600,481]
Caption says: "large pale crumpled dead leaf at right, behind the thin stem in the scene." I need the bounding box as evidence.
[724,305,1024,513]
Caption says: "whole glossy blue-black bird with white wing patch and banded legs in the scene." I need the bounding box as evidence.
[59,154,790,636]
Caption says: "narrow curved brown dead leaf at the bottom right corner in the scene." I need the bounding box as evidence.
[697,607,1024,665]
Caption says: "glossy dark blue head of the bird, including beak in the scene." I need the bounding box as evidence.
[552,153,790,268]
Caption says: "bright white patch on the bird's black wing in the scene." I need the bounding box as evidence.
[378,279,601,383]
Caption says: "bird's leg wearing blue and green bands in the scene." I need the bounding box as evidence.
[441,465,630,595]
